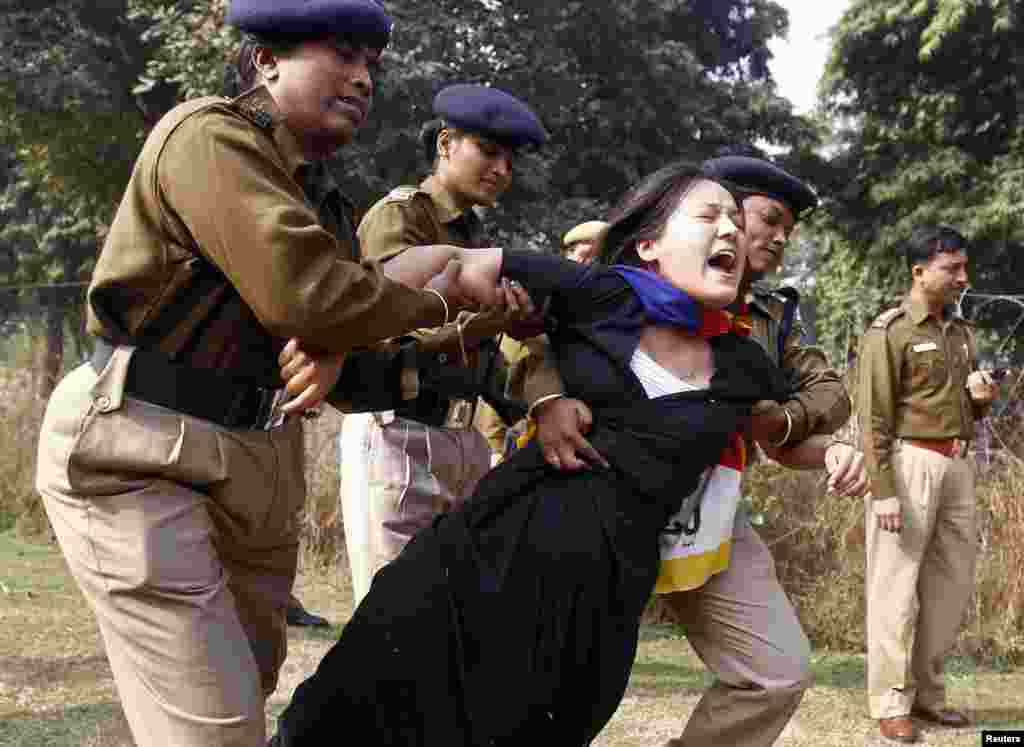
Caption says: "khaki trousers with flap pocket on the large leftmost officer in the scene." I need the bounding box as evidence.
[37,348,305,747]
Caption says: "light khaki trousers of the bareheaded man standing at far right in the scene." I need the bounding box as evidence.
[865,444,977,718]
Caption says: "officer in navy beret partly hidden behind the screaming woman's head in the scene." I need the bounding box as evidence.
[647,155,867,747]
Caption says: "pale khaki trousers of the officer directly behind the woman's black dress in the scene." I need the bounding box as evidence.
[341,415,490,605]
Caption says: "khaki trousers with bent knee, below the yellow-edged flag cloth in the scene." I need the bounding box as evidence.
[665,511,811,747]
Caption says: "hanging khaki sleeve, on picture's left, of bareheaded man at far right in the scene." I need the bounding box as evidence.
[857,327,901,499]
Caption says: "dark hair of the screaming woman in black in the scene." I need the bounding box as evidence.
[597,161,740,265]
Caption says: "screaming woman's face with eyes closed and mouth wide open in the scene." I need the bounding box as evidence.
[637,179,745,308]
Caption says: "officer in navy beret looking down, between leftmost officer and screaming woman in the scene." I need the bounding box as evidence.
[341,85,561,604]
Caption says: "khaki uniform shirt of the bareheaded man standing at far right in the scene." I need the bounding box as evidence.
[857,299,982,500]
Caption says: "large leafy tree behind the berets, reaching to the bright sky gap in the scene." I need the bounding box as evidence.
[132,0,817,241]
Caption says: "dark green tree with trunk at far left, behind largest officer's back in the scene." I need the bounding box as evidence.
[0,0,156,397]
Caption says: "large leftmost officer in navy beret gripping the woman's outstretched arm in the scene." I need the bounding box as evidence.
[37,0,492,747]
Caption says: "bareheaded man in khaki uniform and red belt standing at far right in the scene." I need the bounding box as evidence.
[857,226,996,742]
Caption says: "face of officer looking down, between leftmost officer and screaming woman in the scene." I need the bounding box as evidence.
[437,130,515,207]
